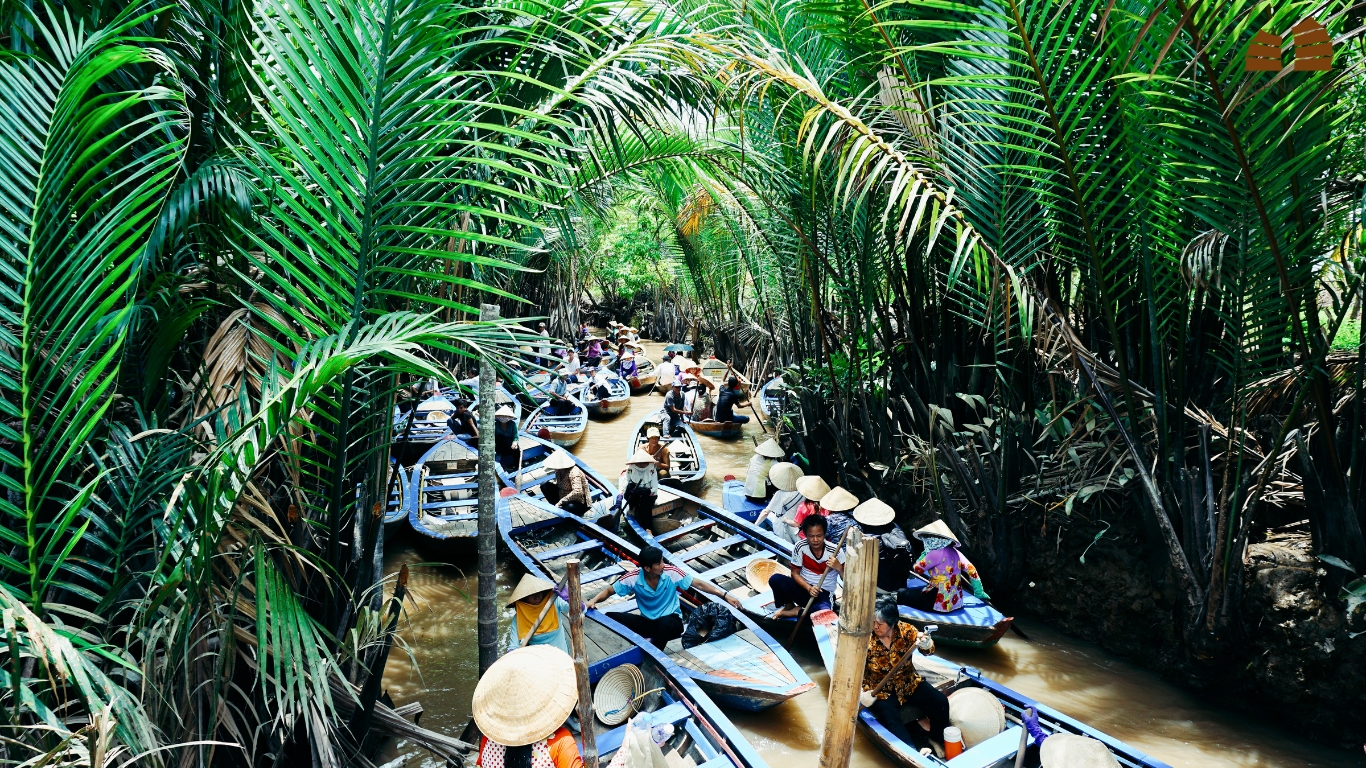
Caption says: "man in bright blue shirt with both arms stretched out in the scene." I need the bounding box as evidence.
[586,547,740,648]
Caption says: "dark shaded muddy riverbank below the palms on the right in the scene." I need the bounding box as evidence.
[1011,502,1366,754]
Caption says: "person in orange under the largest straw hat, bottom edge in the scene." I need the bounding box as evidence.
[471,645,583,768]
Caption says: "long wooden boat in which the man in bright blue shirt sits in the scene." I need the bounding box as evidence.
[497,495,816,712]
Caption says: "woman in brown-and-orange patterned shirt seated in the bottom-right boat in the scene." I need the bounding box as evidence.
[858,597,949,748]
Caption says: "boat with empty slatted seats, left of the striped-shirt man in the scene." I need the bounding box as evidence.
[627,489,795,628]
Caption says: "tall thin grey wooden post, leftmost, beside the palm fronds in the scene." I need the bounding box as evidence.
[478,303,499,678]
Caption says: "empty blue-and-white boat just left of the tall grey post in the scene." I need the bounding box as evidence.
[408,437,479,558]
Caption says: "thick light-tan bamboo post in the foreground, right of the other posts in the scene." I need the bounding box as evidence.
[821,526,877,768]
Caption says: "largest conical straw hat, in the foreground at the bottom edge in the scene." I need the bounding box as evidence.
[473,645,579,746]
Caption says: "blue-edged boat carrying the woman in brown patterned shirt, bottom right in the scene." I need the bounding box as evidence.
[811,611,1171,768]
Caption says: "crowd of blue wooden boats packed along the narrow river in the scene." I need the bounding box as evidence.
[385,330,1165,768]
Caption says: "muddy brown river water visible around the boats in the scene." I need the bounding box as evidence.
[384,342,1366,768]
